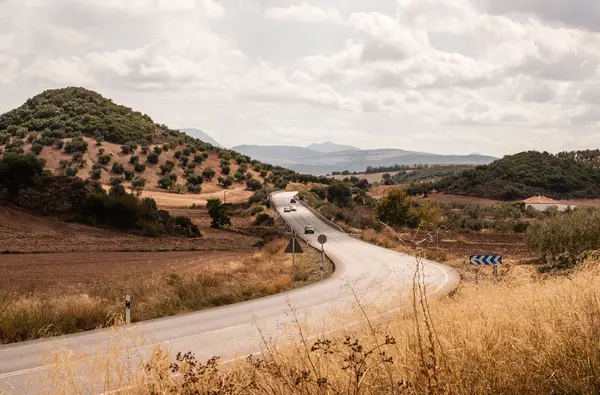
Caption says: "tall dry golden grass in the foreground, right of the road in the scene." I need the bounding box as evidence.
[45,255,600,395]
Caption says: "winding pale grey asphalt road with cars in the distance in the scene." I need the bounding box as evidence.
[0,192,459,394]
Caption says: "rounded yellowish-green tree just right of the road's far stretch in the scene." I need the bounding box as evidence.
[375,188,419,228]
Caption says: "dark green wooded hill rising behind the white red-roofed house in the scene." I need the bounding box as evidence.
[418,150,600,200]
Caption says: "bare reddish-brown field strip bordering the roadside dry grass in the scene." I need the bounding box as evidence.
[0,251,246,296]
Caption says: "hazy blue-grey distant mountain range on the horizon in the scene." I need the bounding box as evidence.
[181,128,498,175]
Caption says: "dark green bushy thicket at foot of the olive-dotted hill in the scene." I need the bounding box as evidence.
[0,153,200,237]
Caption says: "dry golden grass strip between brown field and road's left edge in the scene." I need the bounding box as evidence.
[0,240,333,343]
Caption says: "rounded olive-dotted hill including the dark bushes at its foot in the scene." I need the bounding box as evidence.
[0,87,330,236]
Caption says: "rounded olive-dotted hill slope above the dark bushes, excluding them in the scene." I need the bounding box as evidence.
[0,87,328,193]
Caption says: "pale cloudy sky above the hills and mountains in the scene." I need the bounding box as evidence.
[0,0,600,155]
